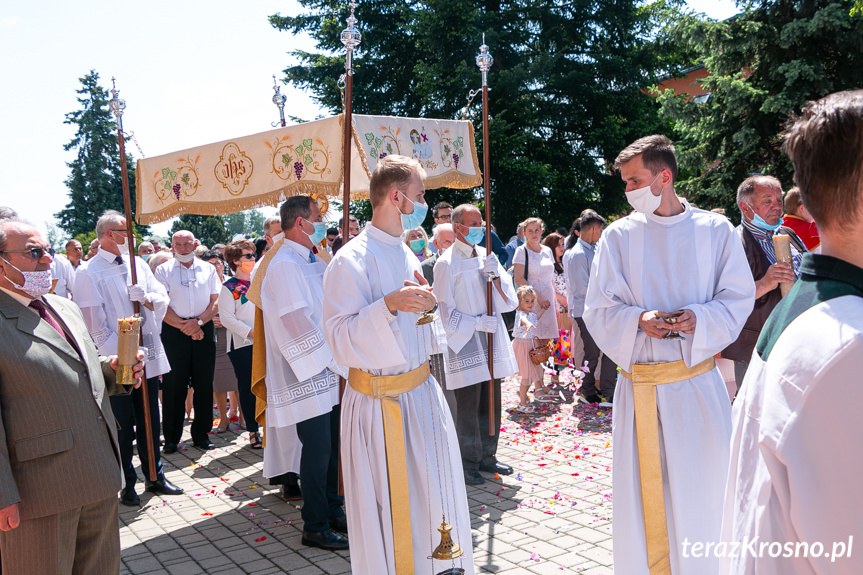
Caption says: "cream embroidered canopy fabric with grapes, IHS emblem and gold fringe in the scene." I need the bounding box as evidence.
[135,115,482,224]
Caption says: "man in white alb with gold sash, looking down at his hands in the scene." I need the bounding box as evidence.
[583,136,755,575]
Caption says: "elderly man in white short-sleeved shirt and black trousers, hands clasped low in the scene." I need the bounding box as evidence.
[155,230,222,453]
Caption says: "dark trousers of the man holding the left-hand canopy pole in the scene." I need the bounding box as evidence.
[108,377,162,487]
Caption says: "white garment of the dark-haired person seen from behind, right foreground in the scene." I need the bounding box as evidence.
[717,294,863,575]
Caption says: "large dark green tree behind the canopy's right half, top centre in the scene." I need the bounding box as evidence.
[270,0,682,237]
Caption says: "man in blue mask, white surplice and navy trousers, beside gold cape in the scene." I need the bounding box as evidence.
[261,196,348,550]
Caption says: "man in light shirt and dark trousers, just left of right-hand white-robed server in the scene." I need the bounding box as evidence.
[563,210,617,407]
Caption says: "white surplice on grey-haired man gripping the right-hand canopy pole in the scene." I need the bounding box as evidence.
[434,240,518,389]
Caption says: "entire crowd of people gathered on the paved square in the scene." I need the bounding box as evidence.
[0,88,863,575]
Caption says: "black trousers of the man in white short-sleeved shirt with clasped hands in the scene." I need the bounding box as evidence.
[162,321,216,443]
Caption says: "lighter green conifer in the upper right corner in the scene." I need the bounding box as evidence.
[659,0,863,215]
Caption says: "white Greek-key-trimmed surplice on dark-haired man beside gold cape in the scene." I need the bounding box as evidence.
[261,239,347,477]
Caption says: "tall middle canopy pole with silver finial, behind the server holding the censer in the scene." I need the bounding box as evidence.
[339,2,362,495]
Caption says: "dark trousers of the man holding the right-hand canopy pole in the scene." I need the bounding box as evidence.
[455,379,500,469]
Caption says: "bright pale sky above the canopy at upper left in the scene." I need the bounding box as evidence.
[0,0,736,238]
